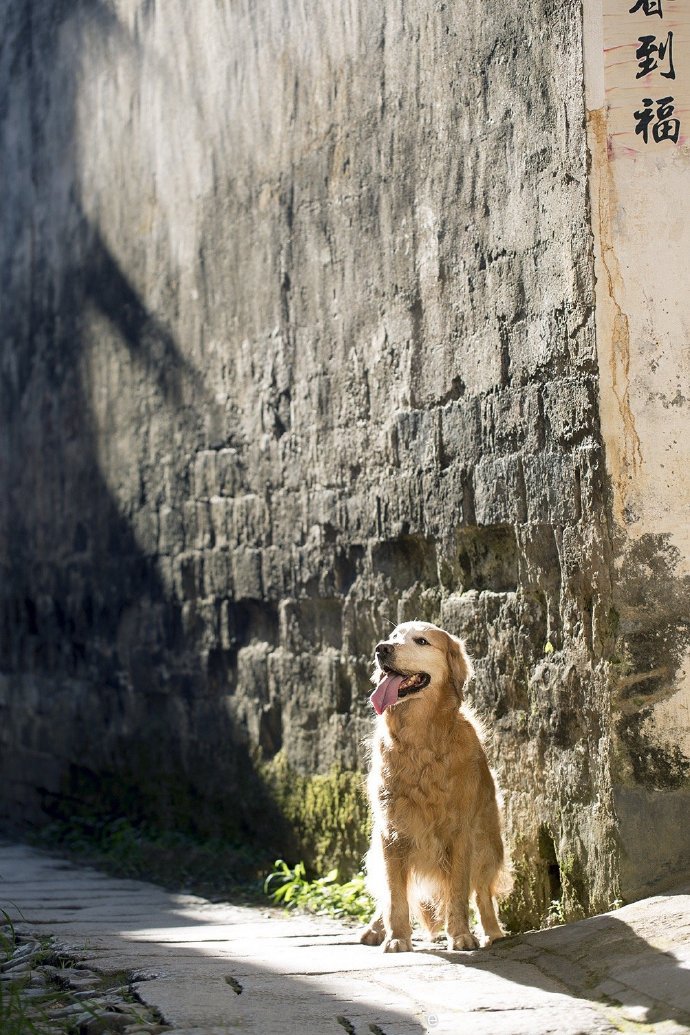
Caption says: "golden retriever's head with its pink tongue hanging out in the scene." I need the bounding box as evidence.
[370,622,473,715]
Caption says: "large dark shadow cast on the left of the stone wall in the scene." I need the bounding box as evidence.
[0,0,283,856]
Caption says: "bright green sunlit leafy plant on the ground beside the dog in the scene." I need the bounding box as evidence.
[264,859,373,922]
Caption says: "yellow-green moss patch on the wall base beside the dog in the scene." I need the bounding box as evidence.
[260,753,370,877]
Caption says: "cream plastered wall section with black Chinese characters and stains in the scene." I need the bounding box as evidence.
[584,0,690,897]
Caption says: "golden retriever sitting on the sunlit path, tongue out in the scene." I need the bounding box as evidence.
[360,622,511,952]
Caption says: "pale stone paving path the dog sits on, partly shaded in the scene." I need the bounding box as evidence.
[0,844,690,1035]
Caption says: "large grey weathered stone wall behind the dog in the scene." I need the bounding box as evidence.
[0,0,617,916]
